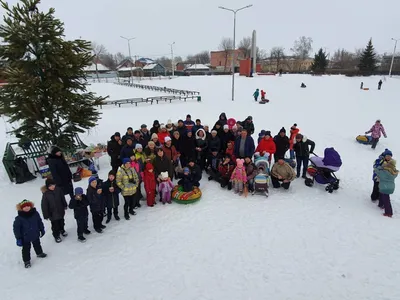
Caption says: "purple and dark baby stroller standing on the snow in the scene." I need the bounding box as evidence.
[304,148,342,193]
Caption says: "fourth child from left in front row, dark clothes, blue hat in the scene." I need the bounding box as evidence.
[86,176,106,233]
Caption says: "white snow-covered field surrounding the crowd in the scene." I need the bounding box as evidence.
[0,75,400,300]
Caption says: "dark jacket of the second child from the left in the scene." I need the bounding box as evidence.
[42,187,68,221]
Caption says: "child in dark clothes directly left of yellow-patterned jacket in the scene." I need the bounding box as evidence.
[102,170,121,224]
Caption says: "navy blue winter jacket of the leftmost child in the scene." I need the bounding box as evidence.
[13,208,44,243]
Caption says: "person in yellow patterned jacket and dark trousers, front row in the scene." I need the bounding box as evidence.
[117,158,139,220]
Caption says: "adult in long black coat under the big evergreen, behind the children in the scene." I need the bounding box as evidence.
[47,146,74,198]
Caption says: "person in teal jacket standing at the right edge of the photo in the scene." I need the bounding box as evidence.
[375,159,399,218]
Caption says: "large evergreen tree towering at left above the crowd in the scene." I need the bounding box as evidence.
[0,0,104,148]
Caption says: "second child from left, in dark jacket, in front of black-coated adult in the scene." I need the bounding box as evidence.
[41,178,68,243]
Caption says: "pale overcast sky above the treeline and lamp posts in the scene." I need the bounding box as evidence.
[1,0,400,58]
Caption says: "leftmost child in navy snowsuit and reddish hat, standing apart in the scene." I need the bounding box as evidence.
[13,200,47,268]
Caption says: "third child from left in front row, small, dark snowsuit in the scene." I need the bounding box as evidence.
[69,187,90,243]
